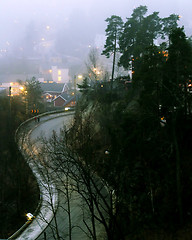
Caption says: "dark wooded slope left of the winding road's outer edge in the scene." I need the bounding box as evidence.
[0,96,38,238]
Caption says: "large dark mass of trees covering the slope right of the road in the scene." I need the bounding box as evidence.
[73,13,192,239]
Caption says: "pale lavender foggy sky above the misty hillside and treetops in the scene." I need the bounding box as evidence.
[0,0,192,57]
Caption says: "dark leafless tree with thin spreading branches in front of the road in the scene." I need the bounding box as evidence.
[38,119,120,240]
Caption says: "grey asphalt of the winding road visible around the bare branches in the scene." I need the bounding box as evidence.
[30,116,103,240]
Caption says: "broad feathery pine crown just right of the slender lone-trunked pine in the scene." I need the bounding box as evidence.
[119,6,179,71]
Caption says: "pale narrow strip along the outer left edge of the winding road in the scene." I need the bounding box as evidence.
[8,111,74,240]
